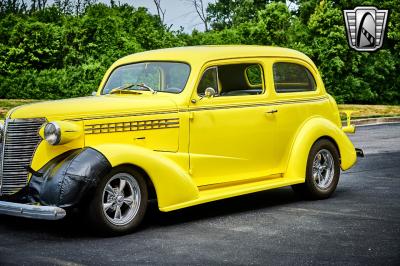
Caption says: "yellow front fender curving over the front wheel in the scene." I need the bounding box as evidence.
[92,144,199,209]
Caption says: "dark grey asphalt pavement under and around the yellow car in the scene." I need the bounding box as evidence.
[0,124,400,265]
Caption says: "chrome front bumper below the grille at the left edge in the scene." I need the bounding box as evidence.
[0,201,66,220]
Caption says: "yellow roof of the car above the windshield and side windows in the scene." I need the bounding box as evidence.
[116,45,315,67]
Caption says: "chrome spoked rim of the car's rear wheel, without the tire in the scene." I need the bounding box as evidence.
[312,149,335,189]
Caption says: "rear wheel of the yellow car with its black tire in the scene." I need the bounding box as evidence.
[292,139,340,199]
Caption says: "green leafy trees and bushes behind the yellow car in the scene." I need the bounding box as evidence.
[0,0,400,104]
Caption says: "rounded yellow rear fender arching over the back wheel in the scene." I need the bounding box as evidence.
[285,117,357,179]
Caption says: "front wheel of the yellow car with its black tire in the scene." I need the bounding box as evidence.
[87,166,148,235]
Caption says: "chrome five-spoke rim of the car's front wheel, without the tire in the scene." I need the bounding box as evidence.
[102,173,141,225]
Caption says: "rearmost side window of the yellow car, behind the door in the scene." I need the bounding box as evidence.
[273,62,316,93]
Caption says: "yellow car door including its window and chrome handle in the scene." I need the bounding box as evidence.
[189,60,276,186]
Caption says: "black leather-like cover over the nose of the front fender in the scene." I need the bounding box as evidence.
[28,148,112,208]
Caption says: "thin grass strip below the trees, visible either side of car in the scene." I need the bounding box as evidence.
[0,99,400,119]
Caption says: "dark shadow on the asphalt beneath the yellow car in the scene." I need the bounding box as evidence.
[0,187,301,239]
